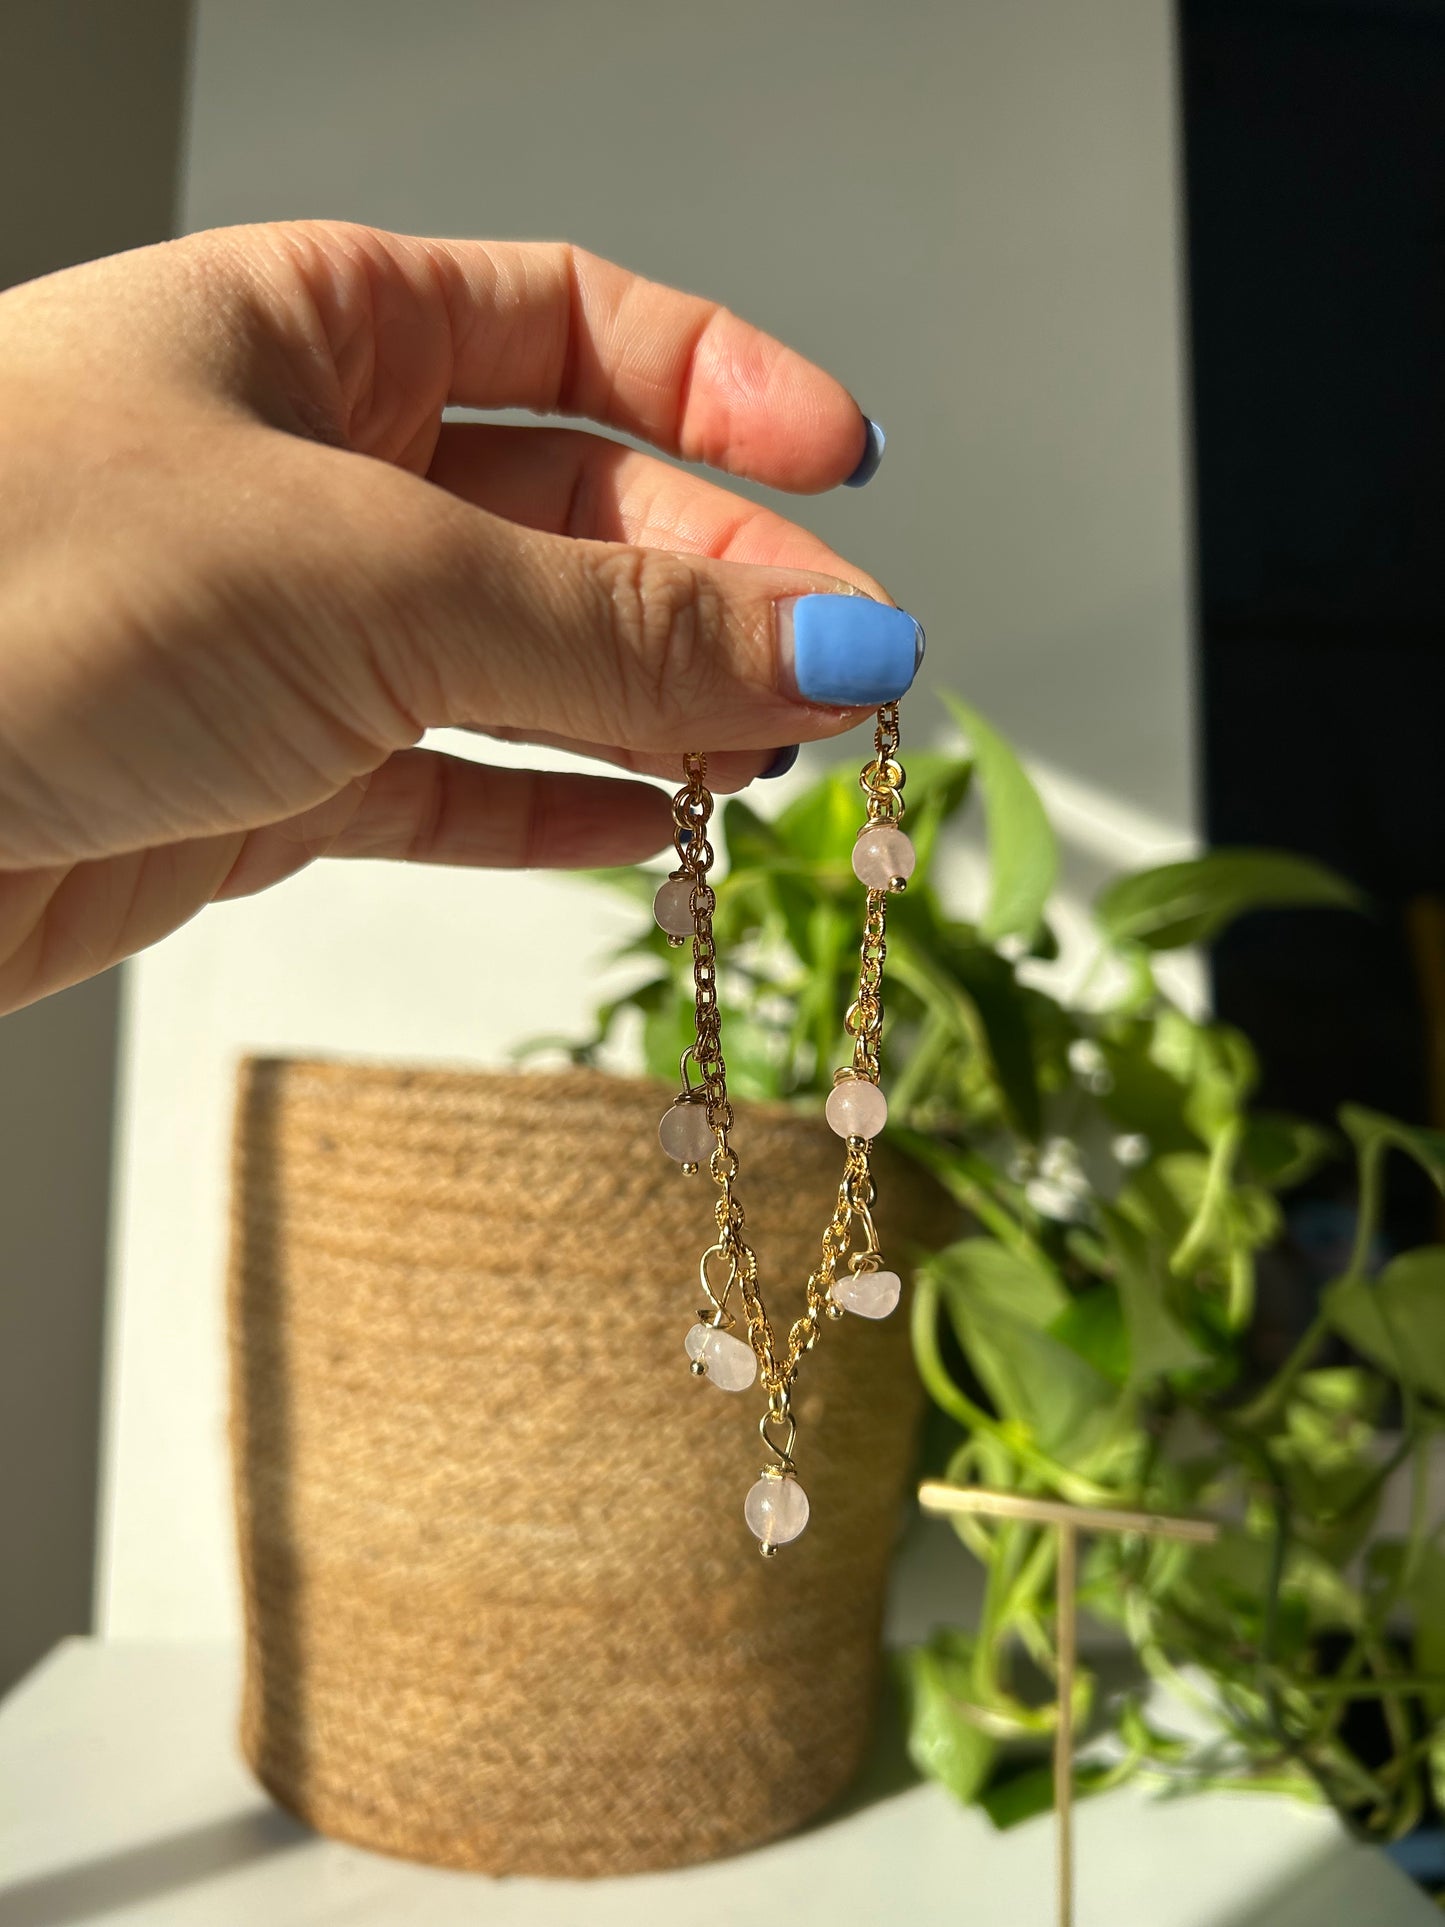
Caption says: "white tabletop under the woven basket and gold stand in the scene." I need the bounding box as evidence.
[0,1640,1439,1927]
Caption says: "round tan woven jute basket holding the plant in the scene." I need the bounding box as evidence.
[229,1062,946,1875]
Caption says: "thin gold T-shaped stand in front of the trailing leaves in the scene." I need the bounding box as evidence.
[919,1478,1220,1927]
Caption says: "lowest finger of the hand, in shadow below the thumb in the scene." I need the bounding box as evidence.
[216,750,672,900]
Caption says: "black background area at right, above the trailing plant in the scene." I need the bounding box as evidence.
[1181,0,1445,1270]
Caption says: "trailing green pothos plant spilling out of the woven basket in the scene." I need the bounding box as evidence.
[551,703,1445,1838]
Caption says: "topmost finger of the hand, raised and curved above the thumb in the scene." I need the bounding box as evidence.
[202,222,871,491]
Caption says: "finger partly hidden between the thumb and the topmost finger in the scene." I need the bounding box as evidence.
[428,422,884,597]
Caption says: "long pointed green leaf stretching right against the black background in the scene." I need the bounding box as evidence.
[1094,850,1362,950]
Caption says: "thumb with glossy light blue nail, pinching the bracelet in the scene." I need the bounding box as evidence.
[362,476,923,752]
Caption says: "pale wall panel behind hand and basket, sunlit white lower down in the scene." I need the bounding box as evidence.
[104,0,1193,1634]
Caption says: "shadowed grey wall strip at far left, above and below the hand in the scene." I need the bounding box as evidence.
[0,0,191,1692]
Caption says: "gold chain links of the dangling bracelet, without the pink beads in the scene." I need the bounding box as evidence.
[672,703,904,1551]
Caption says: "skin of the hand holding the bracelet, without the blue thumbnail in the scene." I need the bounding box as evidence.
[0,224,901,1010]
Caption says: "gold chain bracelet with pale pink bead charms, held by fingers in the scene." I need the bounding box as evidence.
[653,703,913,1557]
